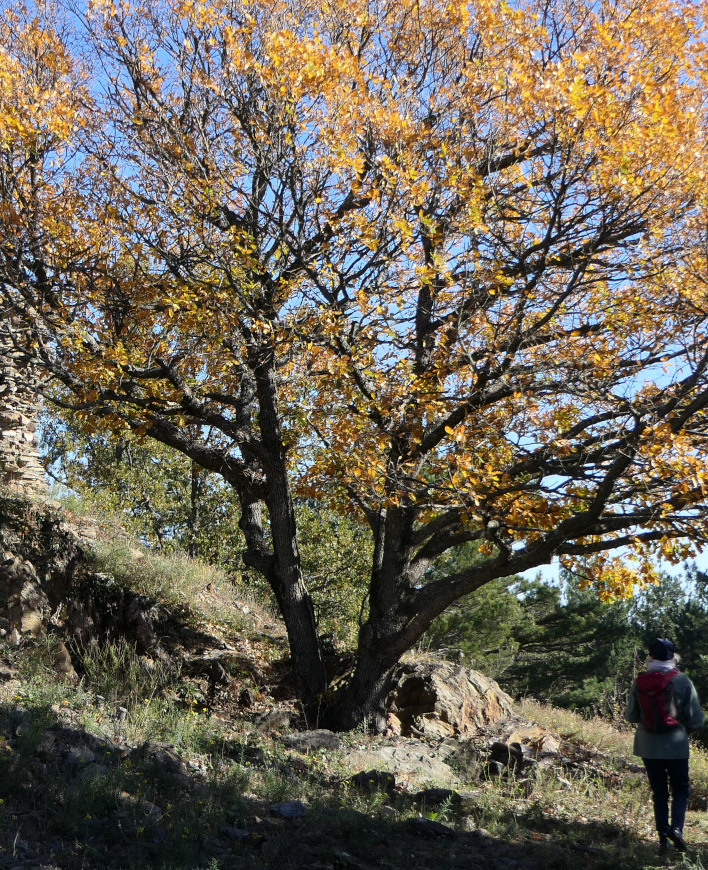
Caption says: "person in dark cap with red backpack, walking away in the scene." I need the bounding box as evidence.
[625,638,705,852]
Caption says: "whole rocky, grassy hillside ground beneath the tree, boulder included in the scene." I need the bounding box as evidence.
[0,494,708,870]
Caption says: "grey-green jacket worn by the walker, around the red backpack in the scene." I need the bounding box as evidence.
[624,674,705,758]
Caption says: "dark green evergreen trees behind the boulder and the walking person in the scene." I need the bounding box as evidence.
[427,567,708,718]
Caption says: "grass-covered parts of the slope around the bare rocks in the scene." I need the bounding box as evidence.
[0,544,708,870]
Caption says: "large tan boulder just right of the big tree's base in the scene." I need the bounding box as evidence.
[386,660,512,739]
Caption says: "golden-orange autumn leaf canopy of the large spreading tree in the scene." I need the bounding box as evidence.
[0,0,708,597]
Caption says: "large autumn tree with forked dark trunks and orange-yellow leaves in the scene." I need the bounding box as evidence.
[0,0,708,728]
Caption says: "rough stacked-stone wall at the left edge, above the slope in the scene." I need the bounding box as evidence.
[0,314,49,496]
